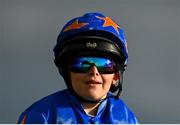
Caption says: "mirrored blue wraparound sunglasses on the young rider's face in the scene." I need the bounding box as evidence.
[69,57,118,74]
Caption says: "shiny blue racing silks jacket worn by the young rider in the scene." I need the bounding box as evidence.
[18,89,138,124]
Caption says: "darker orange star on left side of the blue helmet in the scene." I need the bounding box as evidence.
[63,19,88,32]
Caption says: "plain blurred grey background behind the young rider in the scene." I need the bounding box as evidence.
[0,0,180,124]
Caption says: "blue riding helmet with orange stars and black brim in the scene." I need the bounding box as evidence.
[54,13,128,96]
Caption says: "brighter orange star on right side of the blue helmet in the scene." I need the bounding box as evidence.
[96,16,120,34]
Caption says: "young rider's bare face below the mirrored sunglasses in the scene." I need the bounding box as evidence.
[70,66,115,100]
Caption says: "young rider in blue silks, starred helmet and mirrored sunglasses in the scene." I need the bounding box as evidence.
[18,13,137,124]
